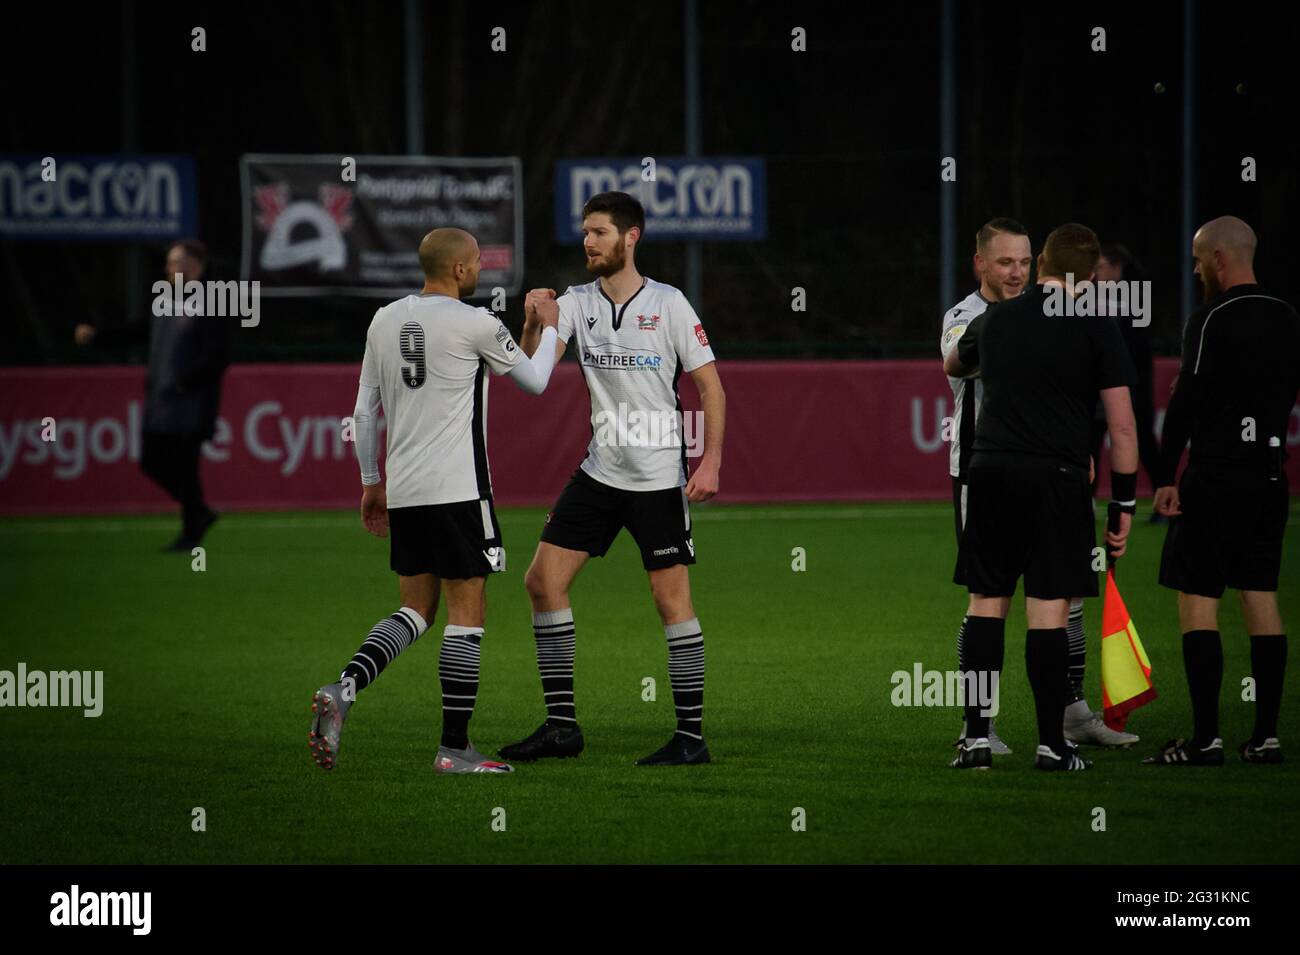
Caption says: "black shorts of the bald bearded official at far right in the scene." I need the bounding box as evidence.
[1160,464,1290,598]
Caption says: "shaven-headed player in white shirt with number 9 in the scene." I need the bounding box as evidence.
[308,229,559,773]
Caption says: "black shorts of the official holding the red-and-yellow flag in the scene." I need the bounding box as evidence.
[953,453,1097,600]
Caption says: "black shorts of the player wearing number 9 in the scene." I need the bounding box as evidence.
[389,498,506,581]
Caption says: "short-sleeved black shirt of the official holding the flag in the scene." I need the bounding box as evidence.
[957,286,1134,469]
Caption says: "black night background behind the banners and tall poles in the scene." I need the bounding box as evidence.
[0,0,1300,364]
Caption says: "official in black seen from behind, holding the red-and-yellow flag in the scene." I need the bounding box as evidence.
[944,222,1138,770]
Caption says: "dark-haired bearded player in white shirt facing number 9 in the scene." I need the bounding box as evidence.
[501,192,725,765]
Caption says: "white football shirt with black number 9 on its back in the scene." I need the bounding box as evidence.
[361,295,523,508]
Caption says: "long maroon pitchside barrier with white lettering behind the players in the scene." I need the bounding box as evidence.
[0,359,1300,515]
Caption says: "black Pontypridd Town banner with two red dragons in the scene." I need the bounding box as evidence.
[241,156,524,299]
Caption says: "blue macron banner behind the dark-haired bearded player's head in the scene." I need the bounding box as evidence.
[555,156,767,242]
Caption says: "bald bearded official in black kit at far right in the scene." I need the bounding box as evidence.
[1144,216,1300,765]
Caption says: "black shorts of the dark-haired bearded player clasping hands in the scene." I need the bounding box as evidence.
[542,468,696,570]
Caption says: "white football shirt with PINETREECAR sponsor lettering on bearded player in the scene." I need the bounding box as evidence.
[558,272,714,491]
